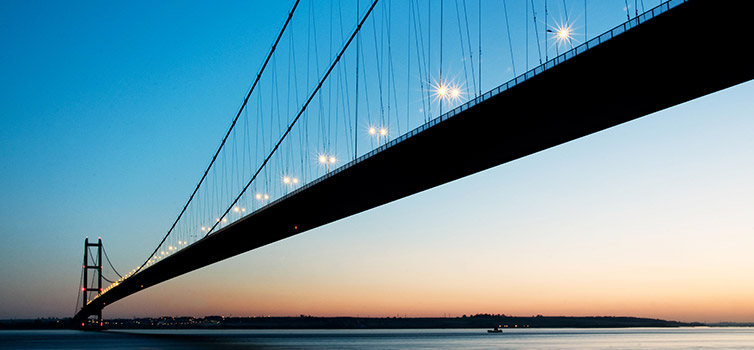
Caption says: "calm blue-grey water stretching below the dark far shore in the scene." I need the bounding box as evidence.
[0,328,754,350]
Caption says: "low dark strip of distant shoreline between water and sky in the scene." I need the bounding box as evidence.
[0,314,740,331]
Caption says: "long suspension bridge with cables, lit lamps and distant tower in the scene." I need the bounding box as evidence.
[74,0,754,327]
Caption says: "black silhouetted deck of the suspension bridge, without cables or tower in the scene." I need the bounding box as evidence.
[77,0,754,318]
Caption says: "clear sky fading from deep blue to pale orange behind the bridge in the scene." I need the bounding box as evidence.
[0,0,754,322]
